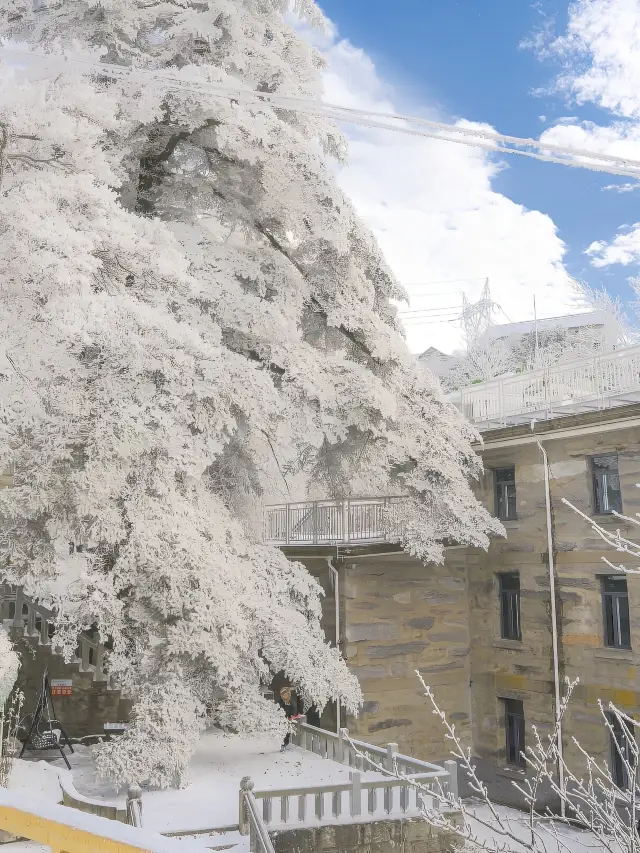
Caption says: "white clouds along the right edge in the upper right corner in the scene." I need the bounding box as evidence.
[541,0,640,267]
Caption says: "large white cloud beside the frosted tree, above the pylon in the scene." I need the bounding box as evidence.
[322,34,574,351]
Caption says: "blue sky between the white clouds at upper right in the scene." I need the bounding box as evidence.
[312,0,640,349]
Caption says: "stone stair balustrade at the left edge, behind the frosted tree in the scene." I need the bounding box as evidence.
[0,584,108,681]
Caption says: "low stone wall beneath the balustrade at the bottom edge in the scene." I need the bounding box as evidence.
[268,820,461,853]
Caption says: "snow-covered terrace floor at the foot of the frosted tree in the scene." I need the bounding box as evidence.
[43,732,364,832]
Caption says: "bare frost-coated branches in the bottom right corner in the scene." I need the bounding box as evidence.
[352,673,640,853]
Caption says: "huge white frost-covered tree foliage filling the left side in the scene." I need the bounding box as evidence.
[0,0,498,784]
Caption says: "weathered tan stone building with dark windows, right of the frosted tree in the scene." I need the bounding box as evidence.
[272,396,640,804]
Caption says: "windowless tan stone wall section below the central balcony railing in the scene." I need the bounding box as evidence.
[341,551,471,762]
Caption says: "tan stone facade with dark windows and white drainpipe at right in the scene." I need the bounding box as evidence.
[466,419,640,804]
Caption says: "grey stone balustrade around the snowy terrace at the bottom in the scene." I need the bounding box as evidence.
[239,721,458,832]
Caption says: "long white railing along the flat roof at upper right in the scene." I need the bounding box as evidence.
[451,346,640,429]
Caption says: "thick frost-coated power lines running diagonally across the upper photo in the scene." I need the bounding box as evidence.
[0,45,640,178]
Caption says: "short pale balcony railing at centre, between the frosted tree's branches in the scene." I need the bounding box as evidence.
[264,497,407,545]
